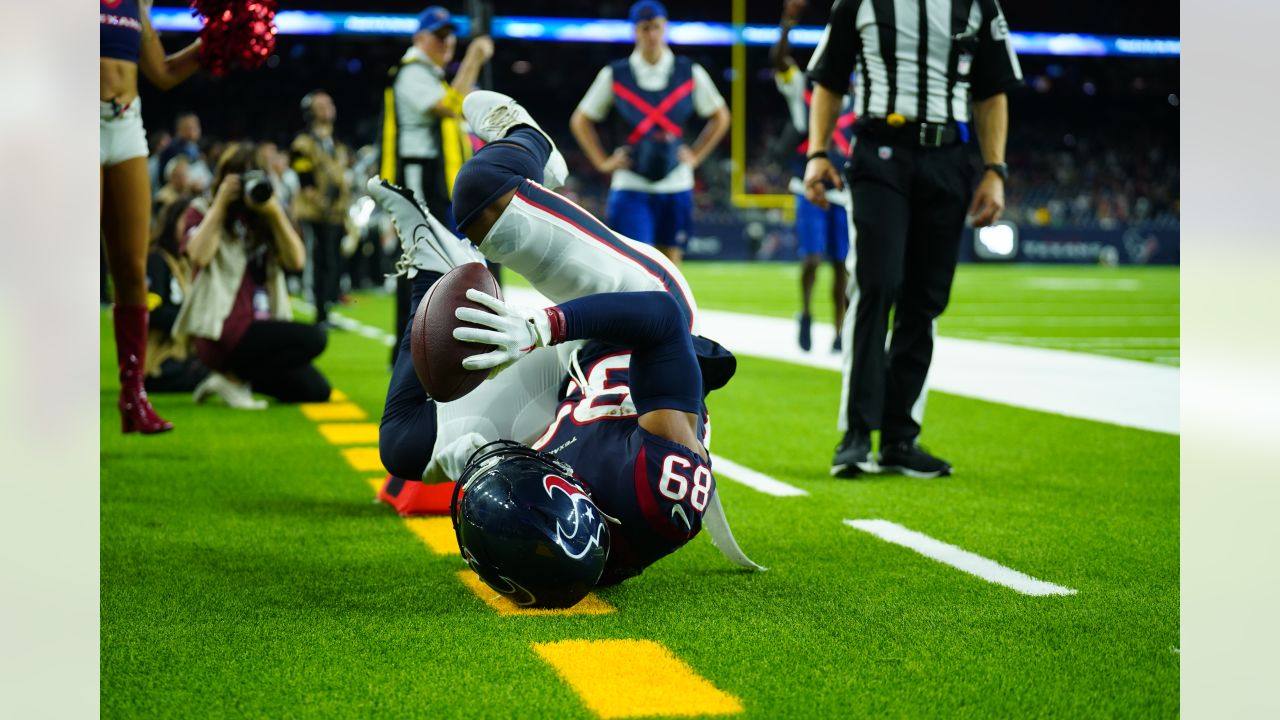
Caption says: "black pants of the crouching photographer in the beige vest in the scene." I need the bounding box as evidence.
[227,320,330,402]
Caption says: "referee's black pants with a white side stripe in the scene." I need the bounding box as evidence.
[844,137,974,446]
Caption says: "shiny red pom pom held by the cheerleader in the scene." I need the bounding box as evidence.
[191,0,276,76]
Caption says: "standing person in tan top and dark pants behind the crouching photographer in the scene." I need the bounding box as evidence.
[291,90,351,325]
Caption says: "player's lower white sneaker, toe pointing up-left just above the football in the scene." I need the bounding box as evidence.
[365,177,484,278]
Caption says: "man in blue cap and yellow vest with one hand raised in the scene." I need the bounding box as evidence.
[379,5,493,365]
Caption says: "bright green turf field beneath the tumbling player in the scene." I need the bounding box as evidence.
[101,265,1179,717]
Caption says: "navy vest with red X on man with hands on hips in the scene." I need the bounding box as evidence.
[609,56,694,182]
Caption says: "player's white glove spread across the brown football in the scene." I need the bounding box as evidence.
[453,288,552,377]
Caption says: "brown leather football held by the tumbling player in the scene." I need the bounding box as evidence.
[410,263,502,402]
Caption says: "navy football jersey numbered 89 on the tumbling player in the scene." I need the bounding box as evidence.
[534,342,716,584]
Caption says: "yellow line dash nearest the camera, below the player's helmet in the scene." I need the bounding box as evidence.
[532,641,742,717]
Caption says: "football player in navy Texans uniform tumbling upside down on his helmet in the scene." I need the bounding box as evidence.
[370,91,758,606]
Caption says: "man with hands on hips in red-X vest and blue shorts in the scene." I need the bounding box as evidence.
[570,0,730,263]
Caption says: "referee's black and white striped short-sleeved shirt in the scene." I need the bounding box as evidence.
[809,0,1023,123]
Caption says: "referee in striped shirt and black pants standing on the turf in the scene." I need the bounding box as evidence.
[804,0,1021,478]
